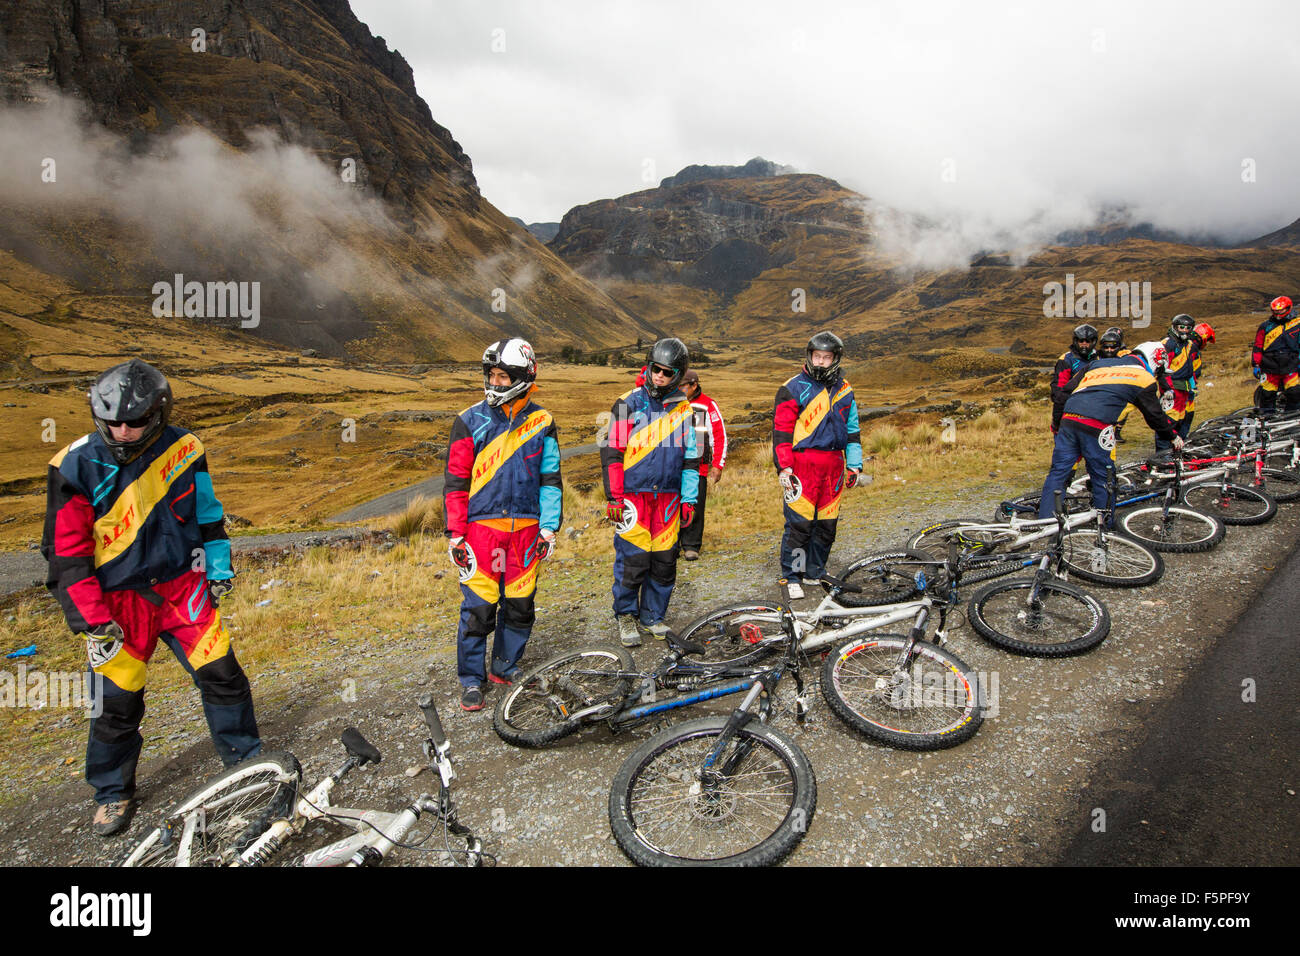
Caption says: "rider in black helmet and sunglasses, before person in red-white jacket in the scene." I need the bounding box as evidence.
[601,338,699,648]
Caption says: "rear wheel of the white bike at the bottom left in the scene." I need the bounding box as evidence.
[122,753,303,866]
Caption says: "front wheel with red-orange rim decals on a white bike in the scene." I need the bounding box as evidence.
[822,633,984,750]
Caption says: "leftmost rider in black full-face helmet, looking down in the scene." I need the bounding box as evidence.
[40,359,261,836]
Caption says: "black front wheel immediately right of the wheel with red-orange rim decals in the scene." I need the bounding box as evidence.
[967,578,1110,657]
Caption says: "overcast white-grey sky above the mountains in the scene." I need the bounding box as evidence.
[352,0,1300,238]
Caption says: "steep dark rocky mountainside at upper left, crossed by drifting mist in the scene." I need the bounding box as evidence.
[0,0,650,360]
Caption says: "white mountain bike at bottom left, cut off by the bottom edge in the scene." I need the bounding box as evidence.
[122,695,495,866]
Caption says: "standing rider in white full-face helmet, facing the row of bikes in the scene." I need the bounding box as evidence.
[443,338,564,710]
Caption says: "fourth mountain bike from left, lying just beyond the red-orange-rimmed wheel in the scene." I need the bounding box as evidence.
[840,492,1110,657]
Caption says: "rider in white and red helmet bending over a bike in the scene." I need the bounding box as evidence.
[1039,342,1183,518]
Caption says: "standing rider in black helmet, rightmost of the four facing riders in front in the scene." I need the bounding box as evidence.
[772,332,862,600]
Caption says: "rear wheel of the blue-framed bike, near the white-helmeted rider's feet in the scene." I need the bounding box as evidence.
[491,646,636,747]
